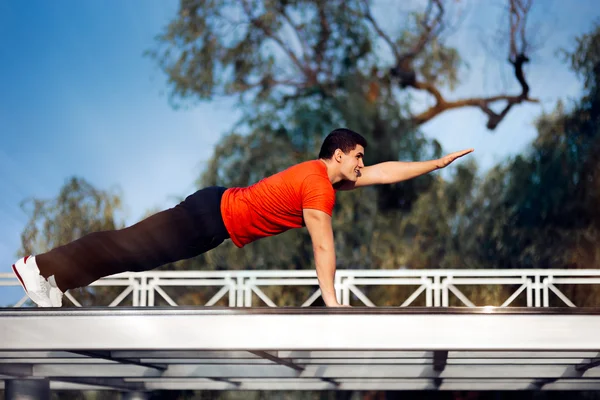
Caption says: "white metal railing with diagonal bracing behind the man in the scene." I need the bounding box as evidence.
[0,269,600,307]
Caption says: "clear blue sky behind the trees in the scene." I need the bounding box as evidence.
[0,0,600,305]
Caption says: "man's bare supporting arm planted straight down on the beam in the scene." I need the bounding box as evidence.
[302,209,340,307]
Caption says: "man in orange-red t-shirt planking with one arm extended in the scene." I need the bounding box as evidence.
[12,129,473,307]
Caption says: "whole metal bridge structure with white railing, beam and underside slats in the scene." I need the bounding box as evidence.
[0,269,600,399]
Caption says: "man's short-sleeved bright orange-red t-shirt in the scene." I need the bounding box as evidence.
[221,160,335,247]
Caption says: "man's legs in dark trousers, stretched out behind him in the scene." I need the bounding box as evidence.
[15,188,228,298]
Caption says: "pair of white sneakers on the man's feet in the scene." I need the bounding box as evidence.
[13,256,63,307]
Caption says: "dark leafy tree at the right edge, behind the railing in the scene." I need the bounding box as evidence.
[459,25,600,306]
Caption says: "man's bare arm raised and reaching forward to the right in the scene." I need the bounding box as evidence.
[336,149,473,190]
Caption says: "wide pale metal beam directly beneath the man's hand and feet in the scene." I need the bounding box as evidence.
[0,308,600,351]
